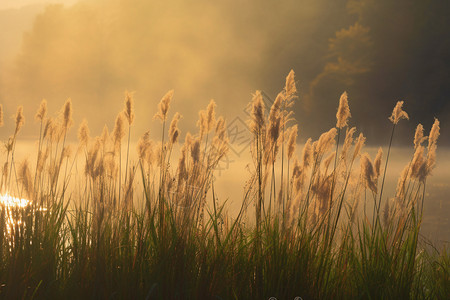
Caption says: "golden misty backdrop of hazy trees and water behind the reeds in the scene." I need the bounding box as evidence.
[0,0,450,240]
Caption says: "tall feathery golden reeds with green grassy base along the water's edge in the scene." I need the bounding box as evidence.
[0,71,450,299]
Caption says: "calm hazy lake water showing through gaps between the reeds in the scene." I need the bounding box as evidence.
[1,141,450,246]
